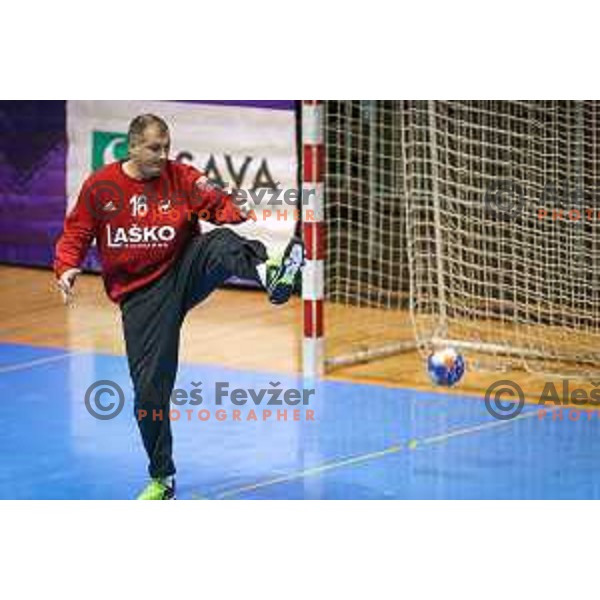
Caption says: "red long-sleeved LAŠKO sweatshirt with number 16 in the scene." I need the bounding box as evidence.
[54,161,244,302]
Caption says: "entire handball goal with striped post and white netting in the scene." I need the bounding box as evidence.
[302,101,600,376]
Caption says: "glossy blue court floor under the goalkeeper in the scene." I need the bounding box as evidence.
[0,344,600,500]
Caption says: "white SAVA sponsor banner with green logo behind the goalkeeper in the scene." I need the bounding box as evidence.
[67,101,297,268]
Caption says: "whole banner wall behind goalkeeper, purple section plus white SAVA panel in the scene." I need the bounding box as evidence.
[0,100,297,278]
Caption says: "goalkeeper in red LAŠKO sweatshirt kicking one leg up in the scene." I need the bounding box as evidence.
[54,114,304,500]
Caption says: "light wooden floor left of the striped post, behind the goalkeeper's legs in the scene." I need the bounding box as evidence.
[0,266,301,373]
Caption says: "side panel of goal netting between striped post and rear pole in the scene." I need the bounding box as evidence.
[325,101,415,367]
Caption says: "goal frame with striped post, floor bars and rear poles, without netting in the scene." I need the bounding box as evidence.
[298,100,598,377]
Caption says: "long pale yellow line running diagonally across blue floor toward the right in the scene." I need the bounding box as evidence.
[213,407,562,500]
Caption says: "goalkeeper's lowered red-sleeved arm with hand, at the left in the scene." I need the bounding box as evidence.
[54,184,96,304]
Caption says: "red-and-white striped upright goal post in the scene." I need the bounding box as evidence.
[302,100,325,377]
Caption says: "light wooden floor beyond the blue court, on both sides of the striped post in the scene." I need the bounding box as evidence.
[0,266,592,399]
